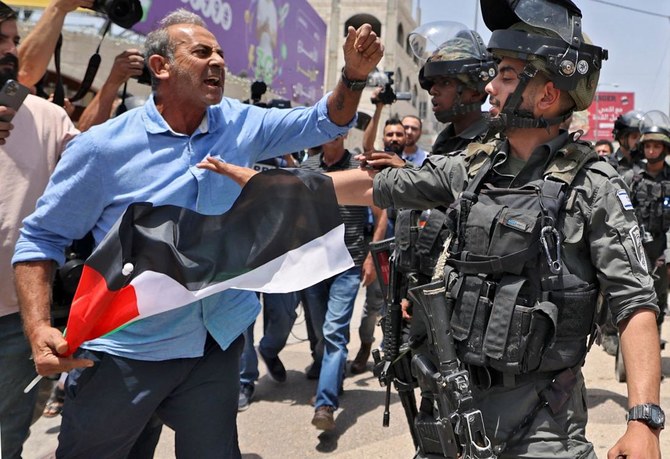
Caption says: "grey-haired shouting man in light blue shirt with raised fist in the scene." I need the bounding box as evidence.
[12,10,383,458]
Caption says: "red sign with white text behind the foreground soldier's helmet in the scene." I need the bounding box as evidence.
[570,92,635,141]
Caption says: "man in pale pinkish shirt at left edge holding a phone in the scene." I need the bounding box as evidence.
[0,2,77,459]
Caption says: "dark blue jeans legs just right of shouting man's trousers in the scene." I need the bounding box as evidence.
[240,292,299,384]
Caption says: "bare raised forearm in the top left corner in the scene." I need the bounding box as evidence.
[18,0,94,87]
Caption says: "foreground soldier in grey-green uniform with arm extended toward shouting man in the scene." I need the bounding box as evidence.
[202,0,665,459]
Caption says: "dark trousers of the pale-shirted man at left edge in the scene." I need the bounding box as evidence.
[0,312,39,459]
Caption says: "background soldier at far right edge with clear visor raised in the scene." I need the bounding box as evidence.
[623,110,670,338]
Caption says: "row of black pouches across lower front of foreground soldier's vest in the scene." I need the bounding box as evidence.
[451,275,598,375]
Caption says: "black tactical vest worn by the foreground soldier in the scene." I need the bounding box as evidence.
[445,142,598,375]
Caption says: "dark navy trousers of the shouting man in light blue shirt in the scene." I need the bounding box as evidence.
[56,336,242,459]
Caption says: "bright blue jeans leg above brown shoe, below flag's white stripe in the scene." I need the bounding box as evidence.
[303,267,361,408]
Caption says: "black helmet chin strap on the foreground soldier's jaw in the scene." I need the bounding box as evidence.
[491,63,572,132]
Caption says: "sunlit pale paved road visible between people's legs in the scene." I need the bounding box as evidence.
[24,295,670,459]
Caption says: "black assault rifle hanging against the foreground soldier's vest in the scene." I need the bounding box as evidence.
[408,276,496,459]
